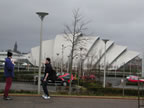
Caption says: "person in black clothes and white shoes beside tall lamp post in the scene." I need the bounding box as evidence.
[42,58,53,99]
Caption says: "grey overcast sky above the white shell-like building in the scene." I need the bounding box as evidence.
[0,0,144,52]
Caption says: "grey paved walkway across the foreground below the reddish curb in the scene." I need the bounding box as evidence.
[0,96,137,108]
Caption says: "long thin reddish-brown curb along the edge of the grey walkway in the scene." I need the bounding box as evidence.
[0,94,138,100]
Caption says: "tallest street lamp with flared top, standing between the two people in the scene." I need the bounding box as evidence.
[36,12,48,94]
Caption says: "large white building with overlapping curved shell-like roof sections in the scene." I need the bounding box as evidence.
[27,35,140,69]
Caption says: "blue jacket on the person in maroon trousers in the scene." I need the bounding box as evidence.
[4,58,14,78]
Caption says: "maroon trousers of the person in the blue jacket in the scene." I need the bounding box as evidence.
[4,77,12,97]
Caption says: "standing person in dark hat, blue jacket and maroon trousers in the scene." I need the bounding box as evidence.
[3,51,14,100]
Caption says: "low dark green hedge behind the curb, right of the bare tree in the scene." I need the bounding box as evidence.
[77,81,138,96]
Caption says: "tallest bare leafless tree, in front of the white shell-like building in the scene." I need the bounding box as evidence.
[64,9,88,94]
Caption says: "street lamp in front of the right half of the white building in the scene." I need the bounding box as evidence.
[102,39,109,88]
